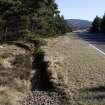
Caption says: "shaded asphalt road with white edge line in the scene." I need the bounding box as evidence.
[76,32,105,53]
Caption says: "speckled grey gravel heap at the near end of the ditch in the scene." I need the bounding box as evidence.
[22,91,59,105]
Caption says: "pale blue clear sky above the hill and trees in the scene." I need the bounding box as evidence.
[56,0,105,21]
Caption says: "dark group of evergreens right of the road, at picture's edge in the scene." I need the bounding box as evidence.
[90,14,105,33]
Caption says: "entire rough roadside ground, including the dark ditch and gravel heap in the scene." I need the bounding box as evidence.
[0,33,105,105]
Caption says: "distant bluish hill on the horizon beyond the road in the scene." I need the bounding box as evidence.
[66,19,92,31]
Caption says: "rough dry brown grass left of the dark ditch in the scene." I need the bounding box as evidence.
[0,44,32,105]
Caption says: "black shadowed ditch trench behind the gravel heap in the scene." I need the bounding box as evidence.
[31,51,54,91]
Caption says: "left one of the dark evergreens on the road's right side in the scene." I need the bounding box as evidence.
[90,16,101,32]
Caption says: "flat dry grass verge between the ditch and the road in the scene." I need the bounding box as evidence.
[43,33,105,105]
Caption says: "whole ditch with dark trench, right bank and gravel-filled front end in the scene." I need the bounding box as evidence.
[24,39,71,105]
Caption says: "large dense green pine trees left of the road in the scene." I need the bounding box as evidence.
[0,0,71,41]
